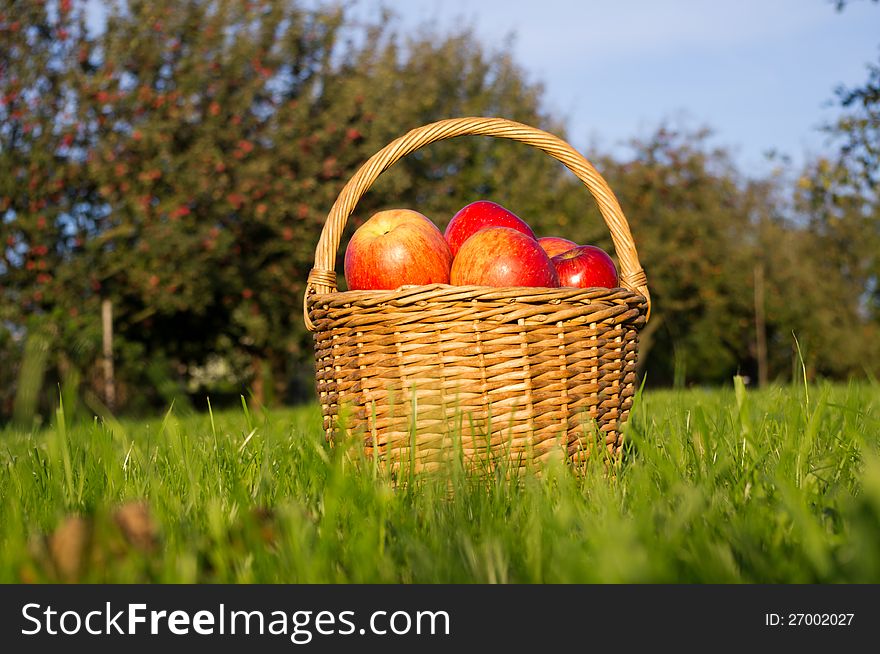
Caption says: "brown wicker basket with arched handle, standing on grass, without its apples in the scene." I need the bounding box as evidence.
[305,118,650,469]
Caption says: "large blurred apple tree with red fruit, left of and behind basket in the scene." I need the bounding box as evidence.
[0,0,576,414]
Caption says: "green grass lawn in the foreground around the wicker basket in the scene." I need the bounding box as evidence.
[0,384,880,583]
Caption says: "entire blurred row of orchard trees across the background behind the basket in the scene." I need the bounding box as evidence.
[0,0,880,420]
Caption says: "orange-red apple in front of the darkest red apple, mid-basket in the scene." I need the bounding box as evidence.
[449,227,559,288]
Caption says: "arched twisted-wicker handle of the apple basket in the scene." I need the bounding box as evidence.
[303,117,651,331]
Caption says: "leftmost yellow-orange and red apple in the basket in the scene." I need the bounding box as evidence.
[344,209,452,290]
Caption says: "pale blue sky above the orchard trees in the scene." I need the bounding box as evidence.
[372,0,880,174]
